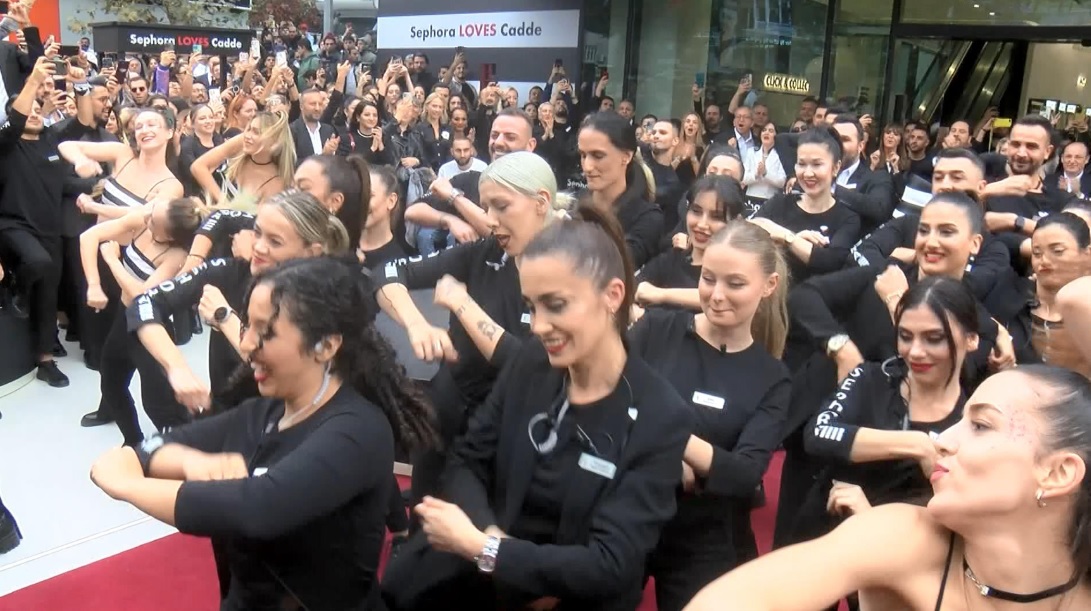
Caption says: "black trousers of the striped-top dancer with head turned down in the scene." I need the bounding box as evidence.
[98,308,190,446]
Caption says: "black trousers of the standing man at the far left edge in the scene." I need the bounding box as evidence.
[0,227,61,359]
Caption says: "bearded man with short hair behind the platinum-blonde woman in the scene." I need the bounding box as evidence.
[405,108,538,250]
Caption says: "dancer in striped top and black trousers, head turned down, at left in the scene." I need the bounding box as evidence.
[80,199,202,445]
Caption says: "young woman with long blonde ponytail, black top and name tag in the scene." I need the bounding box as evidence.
[630,220,791,611]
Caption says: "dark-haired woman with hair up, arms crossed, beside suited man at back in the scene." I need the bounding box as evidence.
[752,128,860,283]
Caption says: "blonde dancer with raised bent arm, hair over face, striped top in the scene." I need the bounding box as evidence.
[190,112,296,207]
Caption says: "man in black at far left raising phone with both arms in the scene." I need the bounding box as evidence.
[0,57,94,387]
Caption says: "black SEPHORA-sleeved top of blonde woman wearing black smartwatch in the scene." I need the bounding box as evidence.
[125,259,260,411]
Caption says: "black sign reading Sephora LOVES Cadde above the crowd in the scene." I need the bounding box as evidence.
[92,23,253,56]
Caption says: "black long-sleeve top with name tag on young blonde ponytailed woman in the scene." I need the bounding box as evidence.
[628,310,791,548]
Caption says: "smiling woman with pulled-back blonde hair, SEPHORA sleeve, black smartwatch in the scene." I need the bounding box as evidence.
[127,191,348,412]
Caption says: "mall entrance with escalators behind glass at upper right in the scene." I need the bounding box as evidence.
[886,24,1091,128]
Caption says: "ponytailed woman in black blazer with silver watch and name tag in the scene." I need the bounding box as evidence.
[384,202,691,610]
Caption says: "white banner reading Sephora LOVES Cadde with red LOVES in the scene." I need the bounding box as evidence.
[376,10,579,49]
